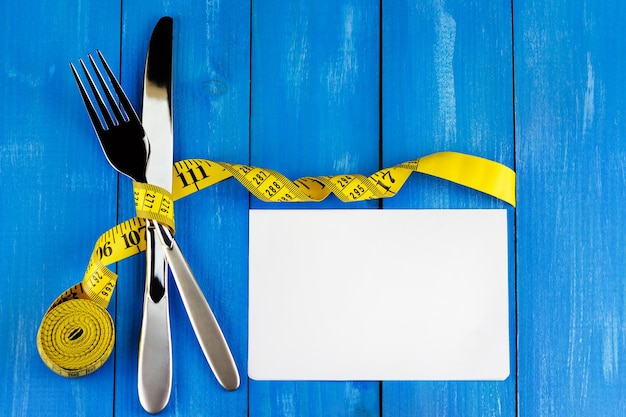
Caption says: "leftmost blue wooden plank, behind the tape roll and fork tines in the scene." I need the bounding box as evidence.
[0,0,119,416]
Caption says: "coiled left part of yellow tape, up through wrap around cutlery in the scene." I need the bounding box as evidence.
[37,183,174,378]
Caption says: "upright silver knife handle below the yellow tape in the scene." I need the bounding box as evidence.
[137,220,172,414]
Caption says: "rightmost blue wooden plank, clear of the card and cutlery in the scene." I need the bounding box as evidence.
[514,0,626,416]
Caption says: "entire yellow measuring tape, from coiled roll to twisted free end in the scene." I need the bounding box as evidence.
[37,152,515,377]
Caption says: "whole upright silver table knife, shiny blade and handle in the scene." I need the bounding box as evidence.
[137,17,174,413]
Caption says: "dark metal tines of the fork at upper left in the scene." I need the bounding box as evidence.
[70,51,139,133]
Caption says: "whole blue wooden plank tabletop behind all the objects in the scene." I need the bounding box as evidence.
[0,0,626,417]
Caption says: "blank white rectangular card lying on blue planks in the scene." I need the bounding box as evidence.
[248,209,509,381]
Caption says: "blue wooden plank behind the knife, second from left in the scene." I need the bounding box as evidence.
[116,1,250,416]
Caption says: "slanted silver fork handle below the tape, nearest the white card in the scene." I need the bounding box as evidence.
[158,224,240,391]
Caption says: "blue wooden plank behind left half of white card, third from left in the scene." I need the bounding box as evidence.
[249,0,379,416]
